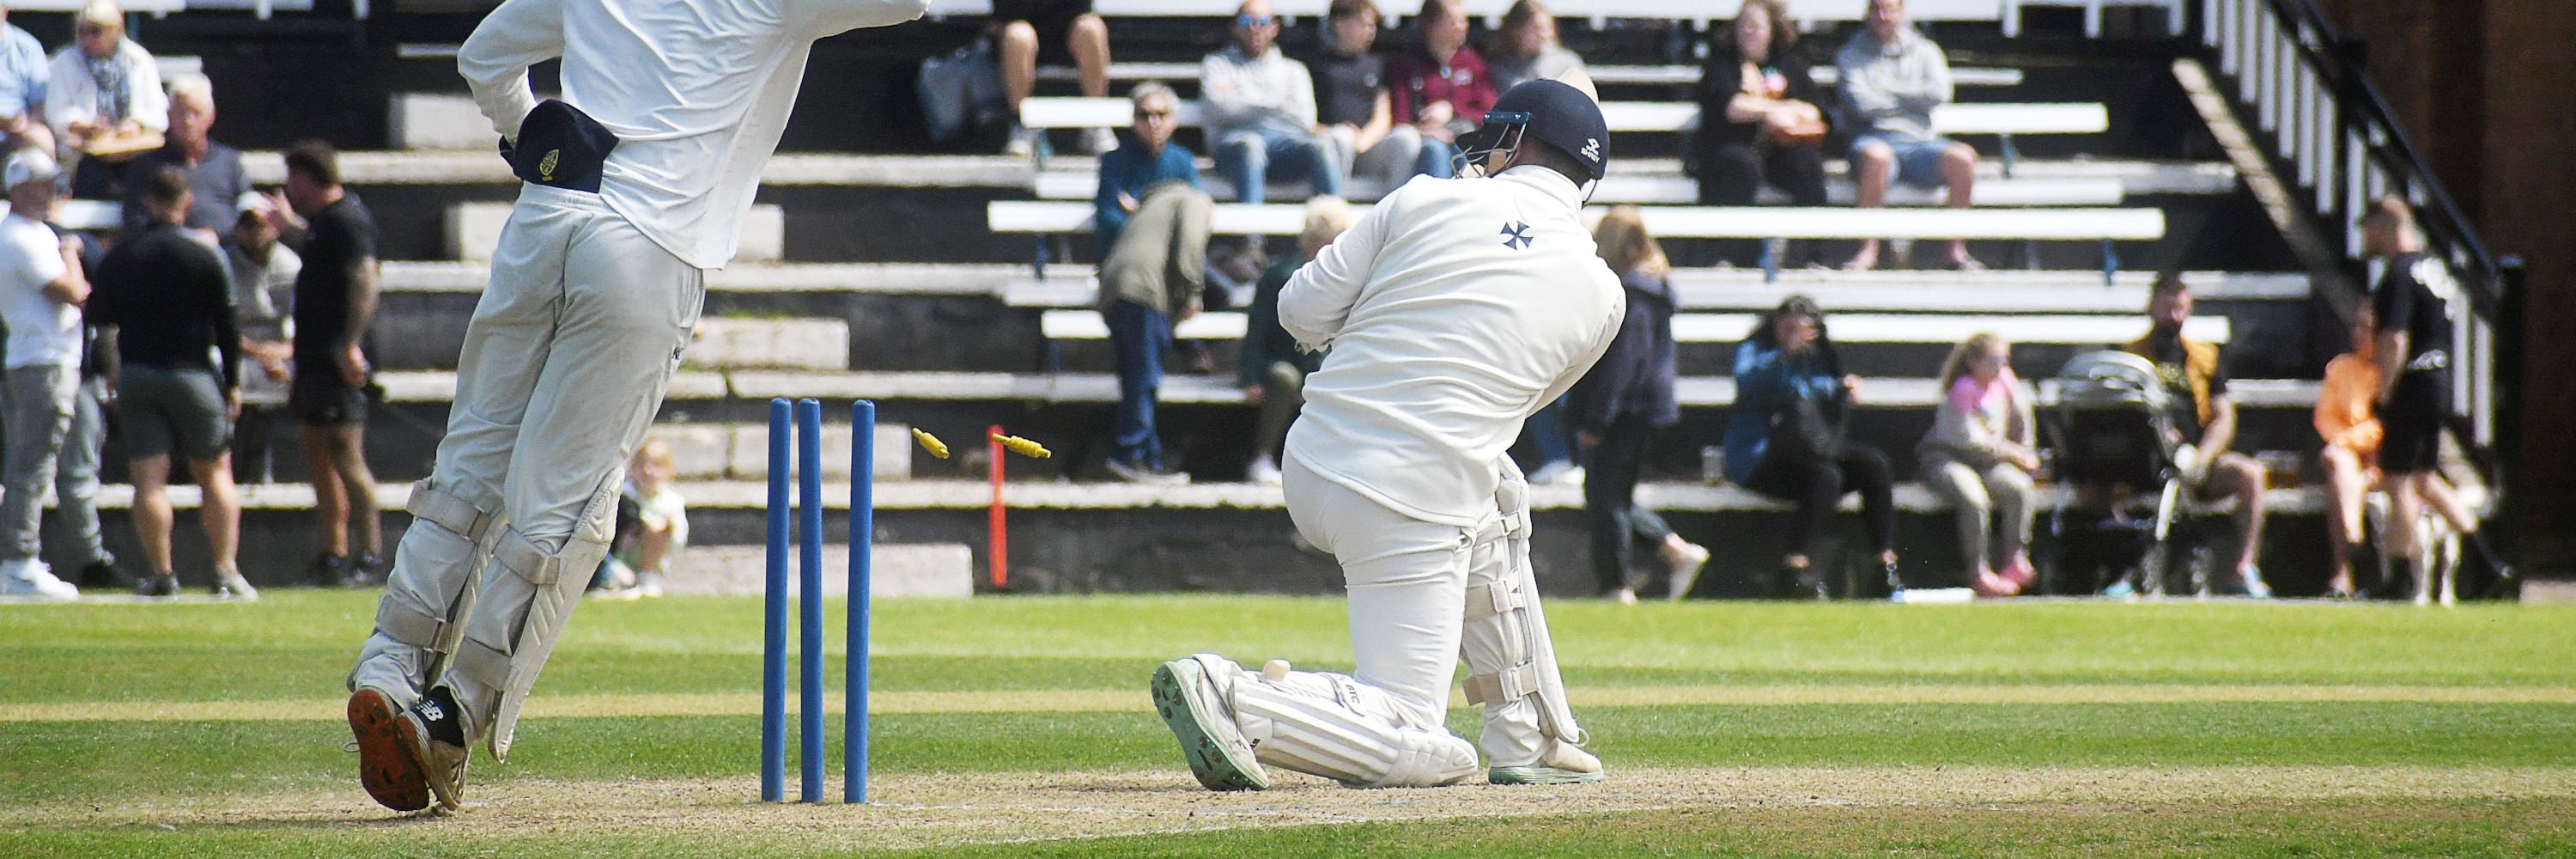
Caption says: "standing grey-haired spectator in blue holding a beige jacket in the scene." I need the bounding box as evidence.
[1092,82,1213,483]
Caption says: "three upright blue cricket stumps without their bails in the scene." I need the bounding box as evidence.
[760,397,876,802]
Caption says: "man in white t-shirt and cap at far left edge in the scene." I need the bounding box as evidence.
[0,149,90,599]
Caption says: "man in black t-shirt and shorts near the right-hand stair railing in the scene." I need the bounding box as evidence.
[2362,196,2514,591]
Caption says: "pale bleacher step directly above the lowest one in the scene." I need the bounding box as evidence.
[376,369,2318,407]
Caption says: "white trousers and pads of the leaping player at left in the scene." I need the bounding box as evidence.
[350,186,706,756]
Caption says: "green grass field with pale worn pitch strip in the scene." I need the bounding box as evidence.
[0,591,2576,856]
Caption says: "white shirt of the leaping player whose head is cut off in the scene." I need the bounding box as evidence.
[456,0,927,268]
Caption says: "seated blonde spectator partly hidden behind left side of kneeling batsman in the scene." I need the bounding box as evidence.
[1234,196,1360,485]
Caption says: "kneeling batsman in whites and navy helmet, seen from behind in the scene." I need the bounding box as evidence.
[1151,80,1625,789]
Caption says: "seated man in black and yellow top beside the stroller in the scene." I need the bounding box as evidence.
[2115,273,2272,599]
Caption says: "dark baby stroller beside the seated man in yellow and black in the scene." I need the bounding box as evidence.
[2043,350,2202,596]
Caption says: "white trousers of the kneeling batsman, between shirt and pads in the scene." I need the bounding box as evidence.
[1280,454,1546,766]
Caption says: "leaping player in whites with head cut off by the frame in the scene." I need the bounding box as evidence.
[348,0,925,810]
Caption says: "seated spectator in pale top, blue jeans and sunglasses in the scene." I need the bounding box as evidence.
[1198,0,1342,204]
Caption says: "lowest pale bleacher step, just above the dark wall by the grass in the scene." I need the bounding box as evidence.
[98,480,2326,516]
